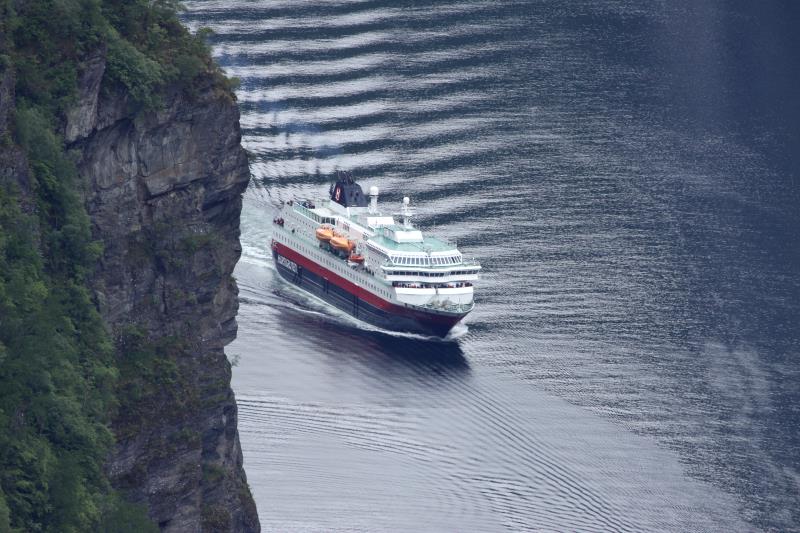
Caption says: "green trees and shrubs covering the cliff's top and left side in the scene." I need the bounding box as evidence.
[0,0,234,532]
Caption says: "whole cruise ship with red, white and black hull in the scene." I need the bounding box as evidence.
[271,173,481,337]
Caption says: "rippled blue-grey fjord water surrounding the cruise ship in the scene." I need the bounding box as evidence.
[185,0,800,531]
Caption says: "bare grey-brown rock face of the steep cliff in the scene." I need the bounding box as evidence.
[64,50,259,532]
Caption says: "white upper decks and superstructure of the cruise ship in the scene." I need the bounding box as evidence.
[274,181,481,311]
